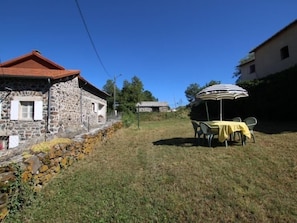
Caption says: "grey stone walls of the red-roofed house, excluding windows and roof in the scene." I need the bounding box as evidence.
[0,77,107,155]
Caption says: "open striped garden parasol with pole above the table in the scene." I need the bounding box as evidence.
[196,84,249,120]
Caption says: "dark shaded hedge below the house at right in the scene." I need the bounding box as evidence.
[235,66,297,120]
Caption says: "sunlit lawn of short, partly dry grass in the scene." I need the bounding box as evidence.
[5,119,297,223]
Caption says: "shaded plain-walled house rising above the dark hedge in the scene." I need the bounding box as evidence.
[238,20,297,82]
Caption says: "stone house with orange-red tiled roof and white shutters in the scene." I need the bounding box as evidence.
[0,51,109,151]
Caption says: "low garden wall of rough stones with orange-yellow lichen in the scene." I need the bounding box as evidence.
[0,121,122,221]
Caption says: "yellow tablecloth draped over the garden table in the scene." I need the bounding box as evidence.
[206,121,251,142]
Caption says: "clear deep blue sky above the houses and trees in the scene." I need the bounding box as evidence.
[0,0,297,107]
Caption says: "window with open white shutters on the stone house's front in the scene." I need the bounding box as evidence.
[10,100,43,120]
